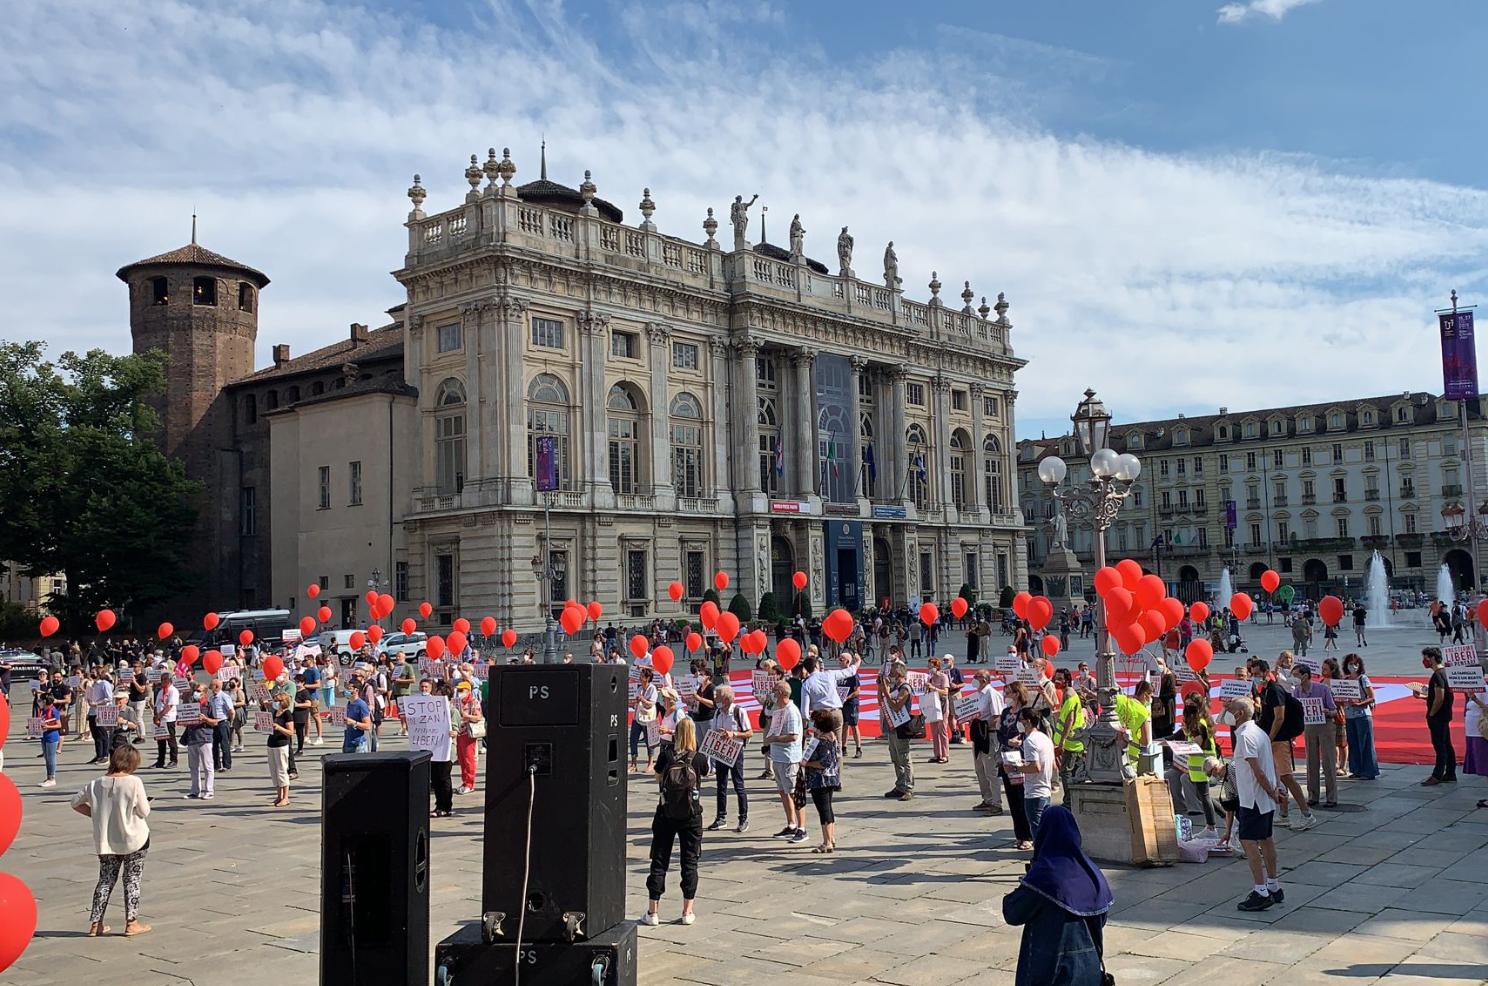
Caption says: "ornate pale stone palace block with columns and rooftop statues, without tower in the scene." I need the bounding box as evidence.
[383,152,1025,629]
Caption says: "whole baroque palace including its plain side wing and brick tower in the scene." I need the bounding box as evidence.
[121,150,1027,629]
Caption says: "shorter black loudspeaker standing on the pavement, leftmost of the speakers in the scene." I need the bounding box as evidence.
[320,751,429,986]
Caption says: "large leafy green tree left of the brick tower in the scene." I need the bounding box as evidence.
[0,342,201,631]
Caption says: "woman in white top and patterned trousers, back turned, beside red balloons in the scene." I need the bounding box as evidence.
[73,744,150,938]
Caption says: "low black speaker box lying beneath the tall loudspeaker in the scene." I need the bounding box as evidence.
[434,921,635,986]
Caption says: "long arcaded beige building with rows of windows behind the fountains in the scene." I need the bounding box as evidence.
[1018,391,1488,598]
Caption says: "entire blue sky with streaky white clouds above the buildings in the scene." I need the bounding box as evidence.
[0,0,1488,436]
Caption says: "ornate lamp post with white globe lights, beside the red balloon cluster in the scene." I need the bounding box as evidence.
[1039,390,1141,784]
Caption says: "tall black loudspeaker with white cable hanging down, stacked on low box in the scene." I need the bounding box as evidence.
[481,665,629,945]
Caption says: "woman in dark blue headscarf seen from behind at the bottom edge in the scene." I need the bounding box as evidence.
[1003,805,1112,986]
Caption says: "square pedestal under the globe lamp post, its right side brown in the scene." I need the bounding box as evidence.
[1070,776,1178,866]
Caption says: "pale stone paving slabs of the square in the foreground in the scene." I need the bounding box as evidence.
[0,723,1488,986]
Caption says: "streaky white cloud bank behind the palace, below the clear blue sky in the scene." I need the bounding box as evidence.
[0,0,1488,431]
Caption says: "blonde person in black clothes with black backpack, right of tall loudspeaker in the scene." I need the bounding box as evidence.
[641,718,708,927]
